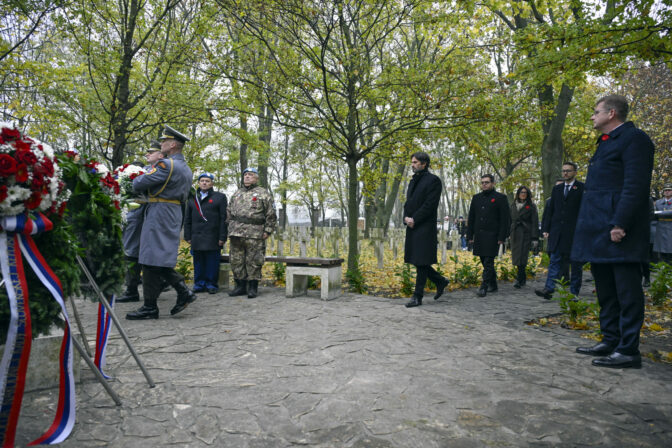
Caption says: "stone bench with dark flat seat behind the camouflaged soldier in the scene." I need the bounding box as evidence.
[219,254,343,300]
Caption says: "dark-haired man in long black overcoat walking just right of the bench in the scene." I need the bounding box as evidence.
[404,152,448,308]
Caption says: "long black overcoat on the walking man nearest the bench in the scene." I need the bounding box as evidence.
[404,169,442,266]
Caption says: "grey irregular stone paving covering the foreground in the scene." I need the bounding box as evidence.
[13,278,672,448]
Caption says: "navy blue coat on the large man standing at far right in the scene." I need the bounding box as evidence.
[572,121,654,263]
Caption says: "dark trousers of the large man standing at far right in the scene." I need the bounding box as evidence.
[591,263,644,355]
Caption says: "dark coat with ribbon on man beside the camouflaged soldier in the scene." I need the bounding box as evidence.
[184,188,227,250]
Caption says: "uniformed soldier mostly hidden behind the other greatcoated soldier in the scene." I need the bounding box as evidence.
[117,140,163,302]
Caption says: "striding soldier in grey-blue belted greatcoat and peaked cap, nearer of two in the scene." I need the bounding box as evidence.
[126,126,196,320]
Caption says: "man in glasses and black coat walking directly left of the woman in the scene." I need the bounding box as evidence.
[467,174,511,297]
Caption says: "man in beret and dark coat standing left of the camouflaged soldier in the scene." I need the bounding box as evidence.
[184,173,227,294]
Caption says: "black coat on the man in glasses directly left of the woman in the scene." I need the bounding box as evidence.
[467,190,511,257]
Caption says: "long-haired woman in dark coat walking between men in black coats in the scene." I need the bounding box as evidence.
[510,185,539,288]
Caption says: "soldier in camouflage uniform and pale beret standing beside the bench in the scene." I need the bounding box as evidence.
[226,168,278,299]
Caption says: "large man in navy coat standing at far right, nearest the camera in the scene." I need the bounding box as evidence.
[572,95,654,368]
